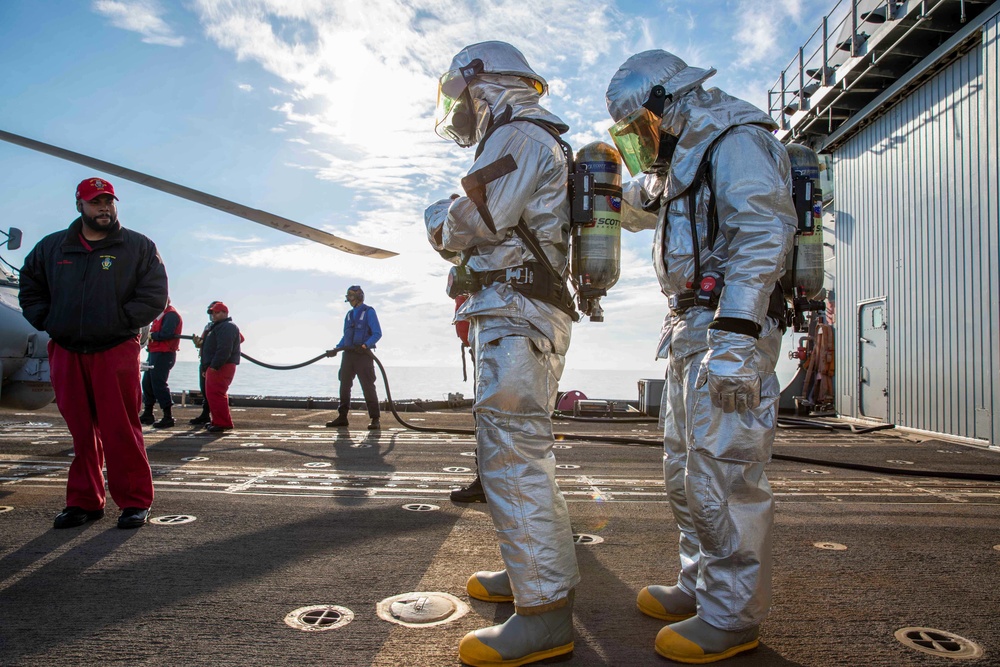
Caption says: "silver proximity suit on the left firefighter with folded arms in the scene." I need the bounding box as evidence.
[425,42,580,613]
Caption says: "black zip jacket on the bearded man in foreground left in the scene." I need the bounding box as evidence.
[18,218,167,353]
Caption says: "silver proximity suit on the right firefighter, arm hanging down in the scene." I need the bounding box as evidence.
[607,51,796,631]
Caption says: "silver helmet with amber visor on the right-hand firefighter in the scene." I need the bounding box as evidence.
[606,50,715,176]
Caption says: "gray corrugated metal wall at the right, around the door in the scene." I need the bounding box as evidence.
[833,11,1000,444]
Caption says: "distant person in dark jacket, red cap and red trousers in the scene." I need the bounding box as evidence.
[201,301,243,433]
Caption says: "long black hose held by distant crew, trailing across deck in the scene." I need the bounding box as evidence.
[174,335,1000,482]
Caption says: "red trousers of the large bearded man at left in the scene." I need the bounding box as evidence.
[49,339,153,511]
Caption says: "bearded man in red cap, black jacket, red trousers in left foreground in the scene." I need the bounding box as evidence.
[19,178,167,528]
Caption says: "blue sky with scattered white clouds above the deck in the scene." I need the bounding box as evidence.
[0,0,834,377]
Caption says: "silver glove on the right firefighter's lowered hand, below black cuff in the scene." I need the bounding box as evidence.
[695,329,760,412]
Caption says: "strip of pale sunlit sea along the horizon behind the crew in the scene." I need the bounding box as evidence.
[169,361,663,401]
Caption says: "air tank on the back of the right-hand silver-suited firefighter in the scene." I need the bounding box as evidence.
[781,144,824,300]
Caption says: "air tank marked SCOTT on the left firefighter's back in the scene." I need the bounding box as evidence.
[571,141,622,322]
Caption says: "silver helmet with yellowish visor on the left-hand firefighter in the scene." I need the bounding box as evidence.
[434,41,549,148]
